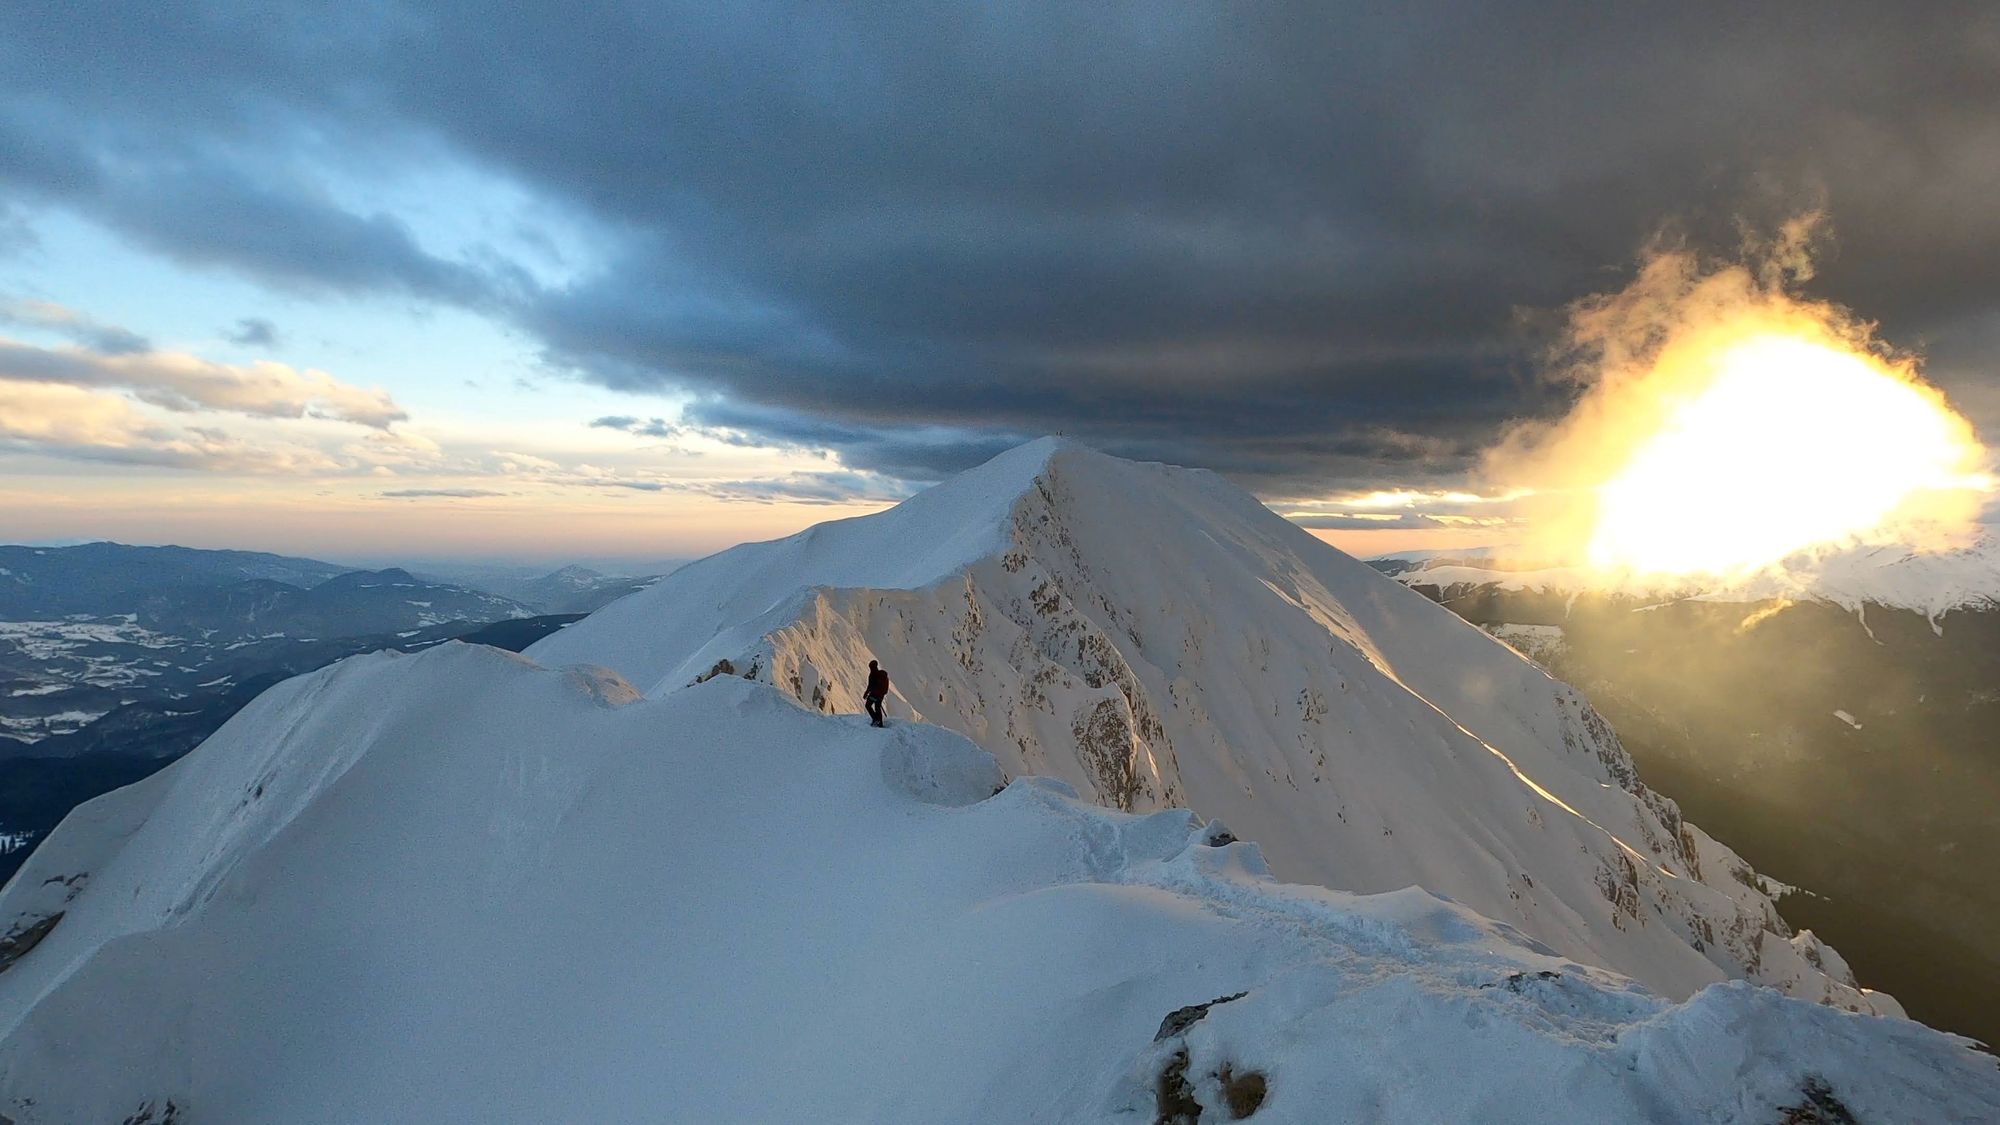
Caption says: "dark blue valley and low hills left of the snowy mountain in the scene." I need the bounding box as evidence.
[0,542,644,879]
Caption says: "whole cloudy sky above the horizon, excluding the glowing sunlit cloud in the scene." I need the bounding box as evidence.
[0,0,2000,558]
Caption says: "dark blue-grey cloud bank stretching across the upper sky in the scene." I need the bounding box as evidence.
[0,0,2000,494]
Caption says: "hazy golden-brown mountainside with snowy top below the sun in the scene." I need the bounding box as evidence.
[1372,540,2000,1041]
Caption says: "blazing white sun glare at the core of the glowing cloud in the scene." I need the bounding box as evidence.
[1588,332,1984,577]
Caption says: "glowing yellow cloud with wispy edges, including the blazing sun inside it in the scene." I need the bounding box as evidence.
[1484,216,1990,579]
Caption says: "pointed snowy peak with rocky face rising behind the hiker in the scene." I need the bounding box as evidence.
[528,438,1900,1013]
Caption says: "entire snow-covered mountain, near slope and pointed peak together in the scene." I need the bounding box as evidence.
[0,442,2000,1125]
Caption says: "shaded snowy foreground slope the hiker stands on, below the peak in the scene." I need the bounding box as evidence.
[0,645,2000,1125]
